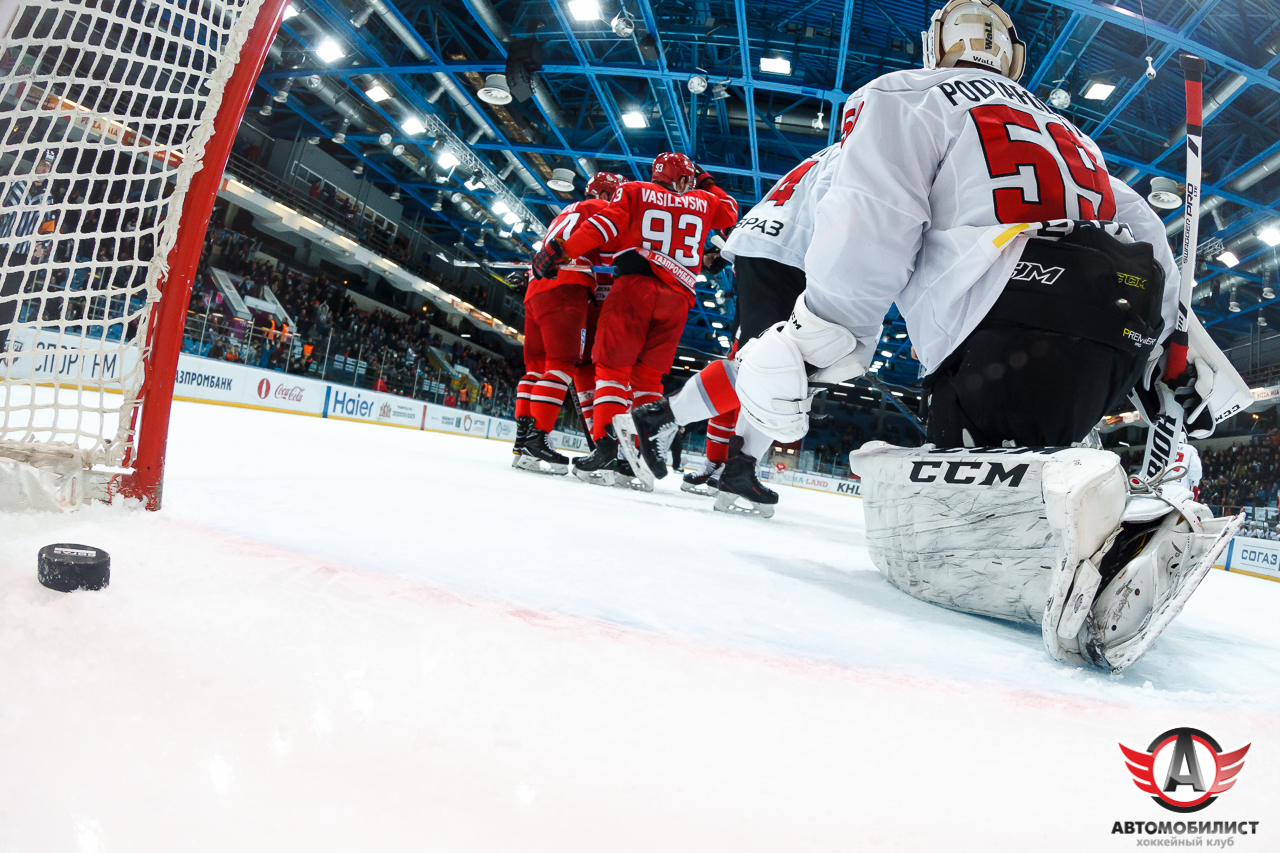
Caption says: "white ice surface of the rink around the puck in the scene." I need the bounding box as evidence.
[0,403,1280,853]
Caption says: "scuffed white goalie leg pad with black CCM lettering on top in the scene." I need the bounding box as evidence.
[850,442,1124,622]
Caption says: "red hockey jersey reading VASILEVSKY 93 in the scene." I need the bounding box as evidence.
[564,181,737,304]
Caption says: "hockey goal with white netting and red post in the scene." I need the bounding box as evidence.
[0,0,285,508]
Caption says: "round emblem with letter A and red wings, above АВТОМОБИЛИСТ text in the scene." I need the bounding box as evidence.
[1120,727,1252,813]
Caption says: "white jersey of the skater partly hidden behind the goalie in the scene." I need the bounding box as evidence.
[722,145,840,269]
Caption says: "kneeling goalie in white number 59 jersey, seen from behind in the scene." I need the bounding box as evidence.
[737,0,1230,669]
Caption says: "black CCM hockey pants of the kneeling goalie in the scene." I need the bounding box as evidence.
[924,229,1164,447]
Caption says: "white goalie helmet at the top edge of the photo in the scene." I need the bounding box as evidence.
[920,0,1027,82]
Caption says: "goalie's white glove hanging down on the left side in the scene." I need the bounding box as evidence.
[736,293,867,443]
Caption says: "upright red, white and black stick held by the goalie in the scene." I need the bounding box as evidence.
[1142,54,1204,479]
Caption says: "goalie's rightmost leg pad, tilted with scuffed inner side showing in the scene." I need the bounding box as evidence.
[1076,499,1243,672]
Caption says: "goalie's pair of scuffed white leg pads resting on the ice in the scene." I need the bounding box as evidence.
[850,442,1240,671]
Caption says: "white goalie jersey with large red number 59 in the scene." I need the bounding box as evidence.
[804,68,1179,371]
